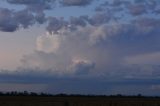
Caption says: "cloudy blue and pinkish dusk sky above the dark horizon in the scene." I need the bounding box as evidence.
[0,0,160,96]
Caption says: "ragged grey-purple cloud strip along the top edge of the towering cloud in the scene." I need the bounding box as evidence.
[46,12,114,33]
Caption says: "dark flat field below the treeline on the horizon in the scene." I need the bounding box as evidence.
[0,96,160,106]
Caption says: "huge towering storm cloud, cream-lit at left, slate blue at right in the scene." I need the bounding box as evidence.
[18,15,159,78]
